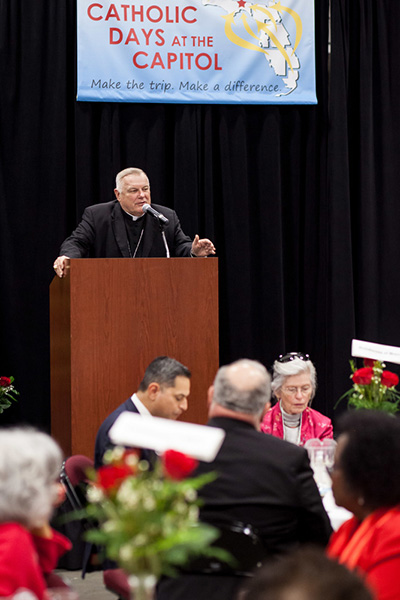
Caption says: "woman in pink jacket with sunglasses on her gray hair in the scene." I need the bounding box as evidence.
[261,352,333,446]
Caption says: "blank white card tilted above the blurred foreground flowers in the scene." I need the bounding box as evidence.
[108,411,225,462]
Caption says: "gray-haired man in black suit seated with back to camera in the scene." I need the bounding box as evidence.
[157,359,332,600]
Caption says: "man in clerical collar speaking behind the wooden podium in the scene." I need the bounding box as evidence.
[53,167,215,277]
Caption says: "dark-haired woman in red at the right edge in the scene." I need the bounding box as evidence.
[328,411,400,600]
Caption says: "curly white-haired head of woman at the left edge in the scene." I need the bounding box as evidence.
[0,428,62,528]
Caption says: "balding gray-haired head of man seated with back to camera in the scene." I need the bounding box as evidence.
[213,359,271,416]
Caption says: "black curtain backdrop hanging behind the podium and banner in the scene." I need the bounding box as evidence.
[0,0,400,428]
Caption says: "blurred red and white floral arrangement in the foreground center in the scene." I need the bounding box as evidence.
[83,447,225,584]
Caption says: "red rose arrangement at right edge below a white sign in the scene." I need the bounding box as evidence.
[339,358,400,414]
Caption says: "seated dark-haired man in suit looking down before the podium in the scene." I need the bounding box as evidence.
[94,356,191,469]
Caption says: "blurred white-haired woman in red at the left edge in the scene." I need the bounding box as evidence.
[0,428,71,600]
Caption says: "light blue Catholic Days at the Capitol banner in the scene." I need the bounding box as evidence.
[77,0,317,104]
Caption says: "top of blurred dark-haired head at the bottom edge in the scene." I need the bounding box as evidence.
[237,548,373,600]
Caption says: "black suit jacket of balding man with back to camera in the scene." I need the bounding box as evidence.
[157,417,332,600]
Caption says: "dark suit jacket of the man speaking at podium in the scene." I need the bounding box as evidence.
[60,200,192,258]
